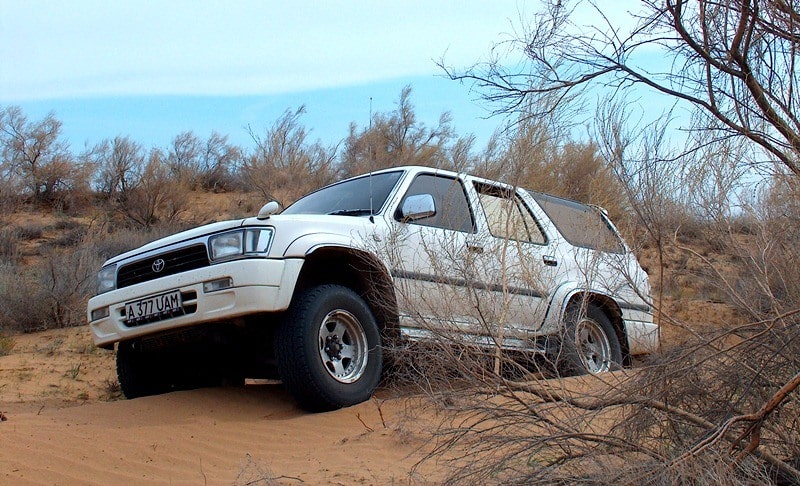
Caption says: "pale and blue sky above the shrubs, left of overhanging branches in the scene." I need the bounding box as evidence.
[0,0,526,151]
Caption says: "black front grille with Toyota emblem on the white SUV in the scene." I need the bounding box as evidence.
[117,244,211,289]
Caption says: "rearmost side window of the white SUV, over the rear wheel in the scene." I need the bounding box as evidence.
[528,191,625,253]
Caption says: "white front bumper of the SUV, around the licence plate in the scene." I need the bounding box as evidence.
[87,258,303,347]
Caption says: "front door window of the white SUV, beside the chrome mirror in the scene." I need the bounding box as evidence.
[395,174,475,233]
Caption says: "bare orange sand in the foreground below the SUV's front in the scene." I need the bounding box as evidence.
[0,328,441,484]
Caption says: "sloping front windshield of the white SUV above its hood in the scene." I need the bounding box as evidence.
[283,171,403,216]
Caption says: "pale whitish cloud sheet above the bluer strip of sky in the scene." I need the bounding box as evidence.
[0,0,517,102]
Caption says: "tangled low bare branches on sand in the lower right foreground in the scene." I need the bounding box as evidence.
[398,310,800,485]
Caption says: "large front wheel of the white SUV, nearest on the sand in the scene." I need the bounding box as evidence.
[275,284,383,412]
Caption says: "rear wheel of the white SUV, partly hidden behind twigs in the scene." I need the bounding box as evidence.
[558,304,622,375]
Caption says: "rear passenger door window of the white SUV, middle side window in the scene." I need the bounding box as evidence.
[475,184,547,245]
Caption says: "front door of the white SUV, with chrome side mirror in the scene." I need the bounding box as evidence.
[387,173,480,337]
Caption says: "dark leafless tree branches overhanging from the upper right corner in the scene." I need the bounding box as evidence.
[446,0,800,175]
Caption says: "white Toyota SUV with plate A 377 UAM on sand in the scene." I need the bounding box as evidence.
[87,167,658,411]
